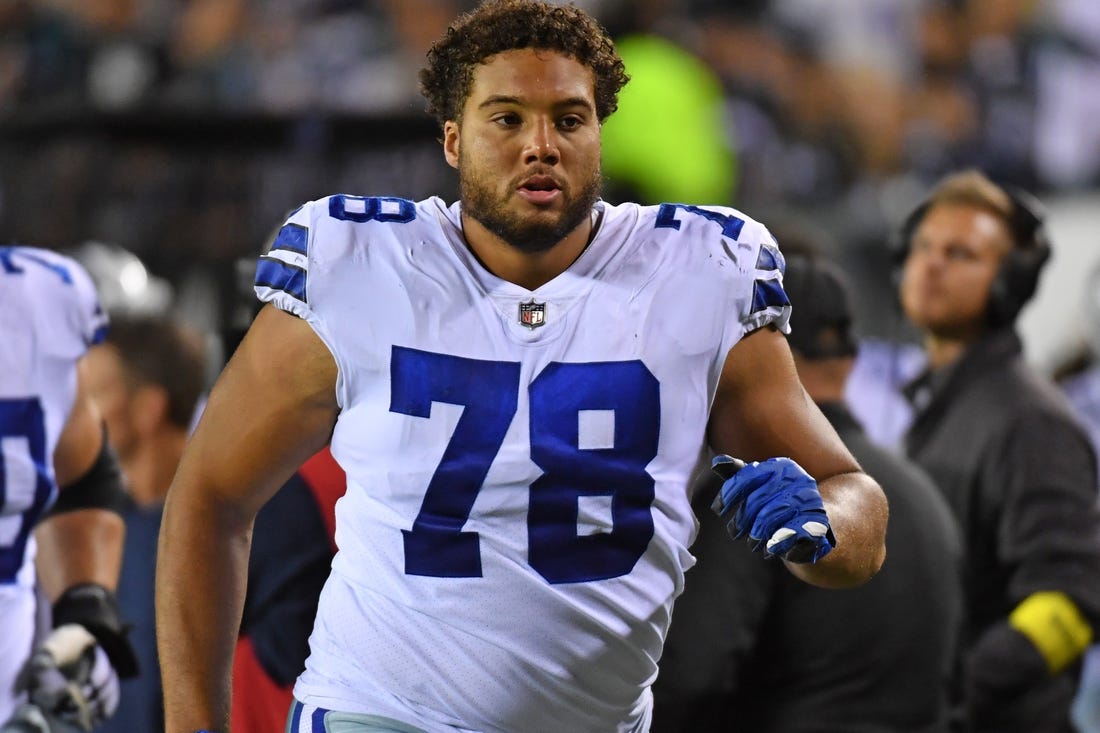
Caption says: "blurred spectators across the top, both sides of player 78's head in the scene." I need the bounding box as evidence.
[0,0,1100,182]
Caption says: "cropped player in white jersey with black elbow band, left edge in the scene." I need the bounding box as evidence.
[0,247,136,731]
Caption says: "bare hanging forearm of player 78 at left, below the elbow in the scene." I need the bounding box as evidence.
[156,485,252,733]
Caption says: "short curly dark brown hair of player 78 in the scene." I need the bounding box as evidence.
[420,0,630,127]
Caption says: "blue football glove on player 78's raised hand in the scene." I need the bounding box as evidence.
[711,456,836,562]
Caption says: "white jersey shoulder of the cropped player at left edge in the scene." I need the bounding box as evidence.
[0,245,107,347]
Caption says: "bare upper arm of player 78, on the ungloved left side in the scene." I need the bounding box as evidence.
[174,306,339,515]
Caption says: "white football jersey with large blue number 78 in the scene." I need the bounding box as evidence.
[256,196,790,733]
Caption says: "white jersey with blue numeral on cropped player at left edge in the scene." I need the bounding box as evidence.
[0,247,107,721]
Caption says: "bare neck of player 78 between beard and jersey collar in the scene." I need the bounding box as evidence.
[462,214,595,291]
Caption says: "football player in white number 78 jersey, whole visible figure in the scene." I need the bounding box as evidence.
[156,0,888,733]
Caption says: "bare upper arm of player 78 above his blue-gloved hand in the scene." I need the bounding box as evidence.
[707,327,859,479]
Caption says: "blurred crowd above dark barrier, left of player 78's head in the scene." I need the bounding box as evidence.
[0,0,461,112]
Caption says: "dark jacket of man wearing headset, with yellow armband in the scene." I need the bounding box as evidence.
[905,329,1100,733]
